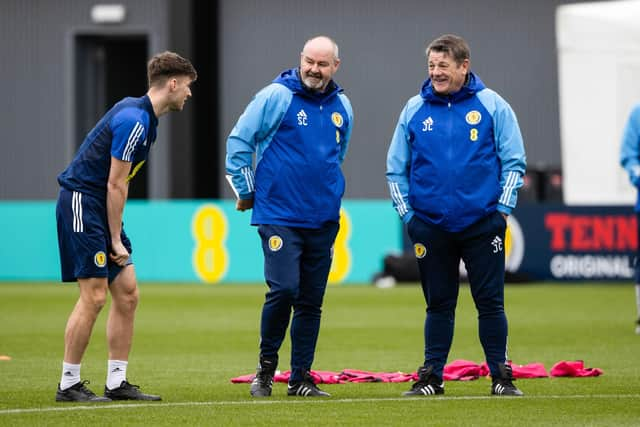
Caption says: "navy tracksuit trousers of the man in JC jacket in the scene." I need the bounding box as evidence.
[407,211,507,378]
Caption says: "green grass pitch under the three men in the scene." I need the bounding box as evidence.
[0,283,640,427]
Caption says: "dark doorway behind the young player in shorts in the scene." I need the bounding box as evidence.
[75,34,152,199]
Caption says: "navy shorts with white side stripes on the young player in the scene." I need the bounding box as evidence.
[56,188,132,283]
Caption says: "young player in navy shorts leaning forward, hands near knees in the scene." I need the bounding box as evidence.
[56,52,197,402]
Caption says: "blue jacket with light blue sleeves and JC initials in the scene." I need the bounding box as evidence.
[386,73,526,232]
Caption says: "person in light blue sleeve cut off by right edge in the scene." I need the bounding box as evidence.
[620,104,640,335]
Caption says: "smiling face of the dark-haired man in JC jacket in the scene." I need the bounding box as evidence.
[427,50,469,95]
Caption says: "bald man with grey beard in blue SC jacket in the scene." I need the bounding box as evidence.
[226,36,353,397]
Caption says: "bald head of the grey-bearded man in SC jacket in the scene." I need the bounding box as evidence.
[300,36,340,92]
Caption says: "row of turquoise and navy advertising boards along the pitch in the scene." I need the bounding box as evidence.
[0,200,638,284]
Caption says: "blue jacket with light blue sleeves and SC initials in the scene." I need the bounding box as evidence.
[226,68,353,228]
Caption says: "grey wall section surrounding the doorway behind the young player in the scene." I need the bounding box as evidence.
[0,0,169,200]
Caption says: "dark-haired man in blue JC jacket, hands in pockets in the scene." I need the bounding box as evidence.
[387,35,526,396]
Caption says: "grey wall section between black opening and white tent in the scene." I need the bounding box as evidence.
[219,0,584,198]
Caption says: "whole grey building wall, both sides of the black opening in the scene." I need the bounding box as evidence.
[0,0,600,199]
